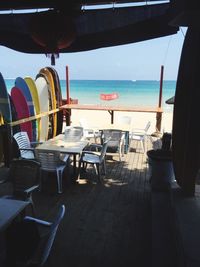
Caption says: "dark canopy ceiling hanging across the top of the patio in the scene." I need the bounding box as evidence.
[0,0,178,54]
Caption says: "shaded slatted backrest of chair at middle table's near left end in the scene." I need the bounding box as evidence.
[35,149,60,171]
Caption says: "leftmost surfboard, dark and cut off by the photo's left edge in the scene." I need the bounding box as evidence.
[0,73,12,166]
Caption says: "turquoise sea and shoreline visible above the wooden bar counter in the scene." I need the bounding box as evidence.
[5,79,176,112]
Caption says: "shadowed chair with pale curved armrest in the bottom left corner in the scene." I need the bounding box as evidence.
[6,205,65,267]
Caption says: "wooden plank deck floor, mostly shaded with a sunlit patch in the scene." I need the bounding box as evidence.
[0,140,159,267]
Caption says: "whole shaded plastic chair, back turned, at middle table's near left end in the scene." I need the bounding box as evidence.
[35,149,69,194]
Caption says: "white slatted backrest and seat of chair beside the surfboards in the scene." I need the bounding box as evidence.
[13,132,34,159]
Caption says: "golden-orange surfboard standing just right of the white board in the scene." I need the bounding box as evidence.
[39,68,57,137]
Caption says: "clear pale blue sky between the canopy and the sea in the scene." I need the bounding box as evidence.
[0,28,186,80]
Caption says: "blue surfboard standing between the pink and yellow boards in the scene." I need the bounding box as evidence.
[15,77,37,141]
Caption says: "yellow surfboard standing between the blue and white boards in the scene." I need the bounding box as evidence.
[24,77,41,141]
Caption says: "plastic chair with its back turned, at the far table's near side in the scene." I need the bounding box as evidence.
[101,129,125,161]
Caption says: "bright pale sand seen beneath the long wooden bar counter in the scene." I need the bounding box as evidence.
[71,110,173,134]
